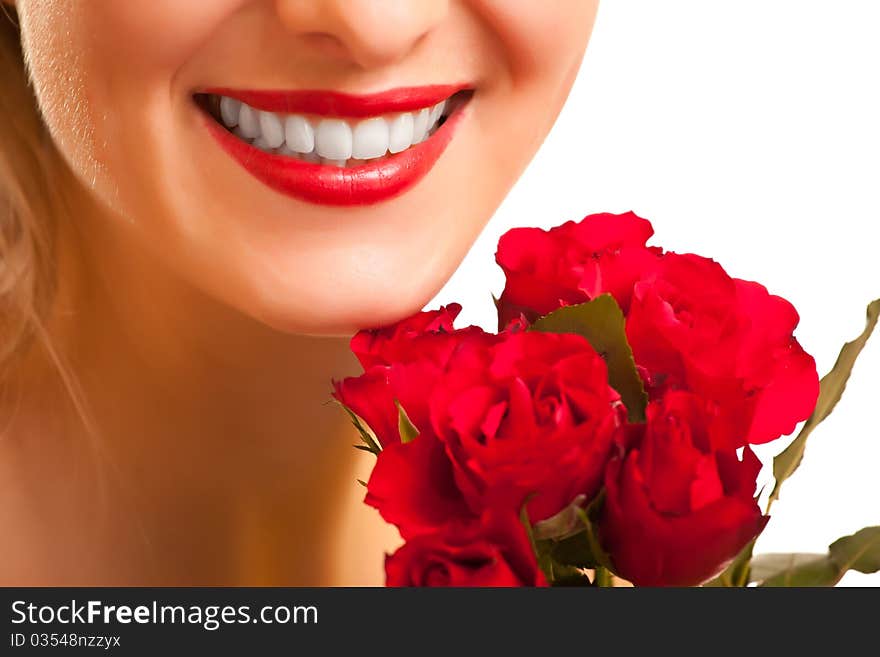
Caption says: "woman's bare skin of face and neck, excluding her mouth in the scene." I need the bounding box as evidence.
[0,0,598,584]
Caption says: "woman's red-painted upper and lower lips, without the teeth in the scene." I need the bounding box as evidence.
[205,85,464,206]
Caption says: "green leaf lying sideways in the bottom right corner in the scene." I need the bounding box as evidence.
[752,526,880,587]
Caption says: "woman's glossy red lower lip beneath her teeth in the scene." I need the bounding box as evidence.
[204,107,467,206]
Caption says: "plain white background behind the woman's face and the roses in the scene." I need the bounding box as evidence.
[430,0,880,586]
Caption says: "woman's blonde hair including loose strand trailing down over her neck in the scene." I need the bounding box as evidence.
[0,12,157,544]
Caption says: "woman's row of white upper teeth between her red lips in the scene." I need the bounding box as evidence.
[214,96,446,166]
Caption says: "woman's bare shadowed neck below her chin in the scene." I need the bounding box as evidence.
[2,164,396,584]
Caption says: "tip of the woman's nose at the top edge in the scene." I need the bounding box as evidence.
[276,0,449,69]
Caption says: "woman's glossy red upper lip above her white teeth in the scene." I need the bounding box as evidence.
[202,84,471,118]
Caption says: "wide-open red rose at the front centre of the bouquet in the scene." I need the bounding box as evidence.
[430,332,625,522]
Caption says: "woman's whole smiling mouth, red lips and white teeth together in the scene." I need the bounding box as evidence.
[195,84,473,205]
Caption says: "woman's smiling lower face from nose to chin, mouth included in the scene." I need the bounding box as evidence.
[18,0,597,335]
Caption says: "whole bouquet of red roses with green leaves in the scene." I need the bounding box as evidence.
[334,213,880,586]
